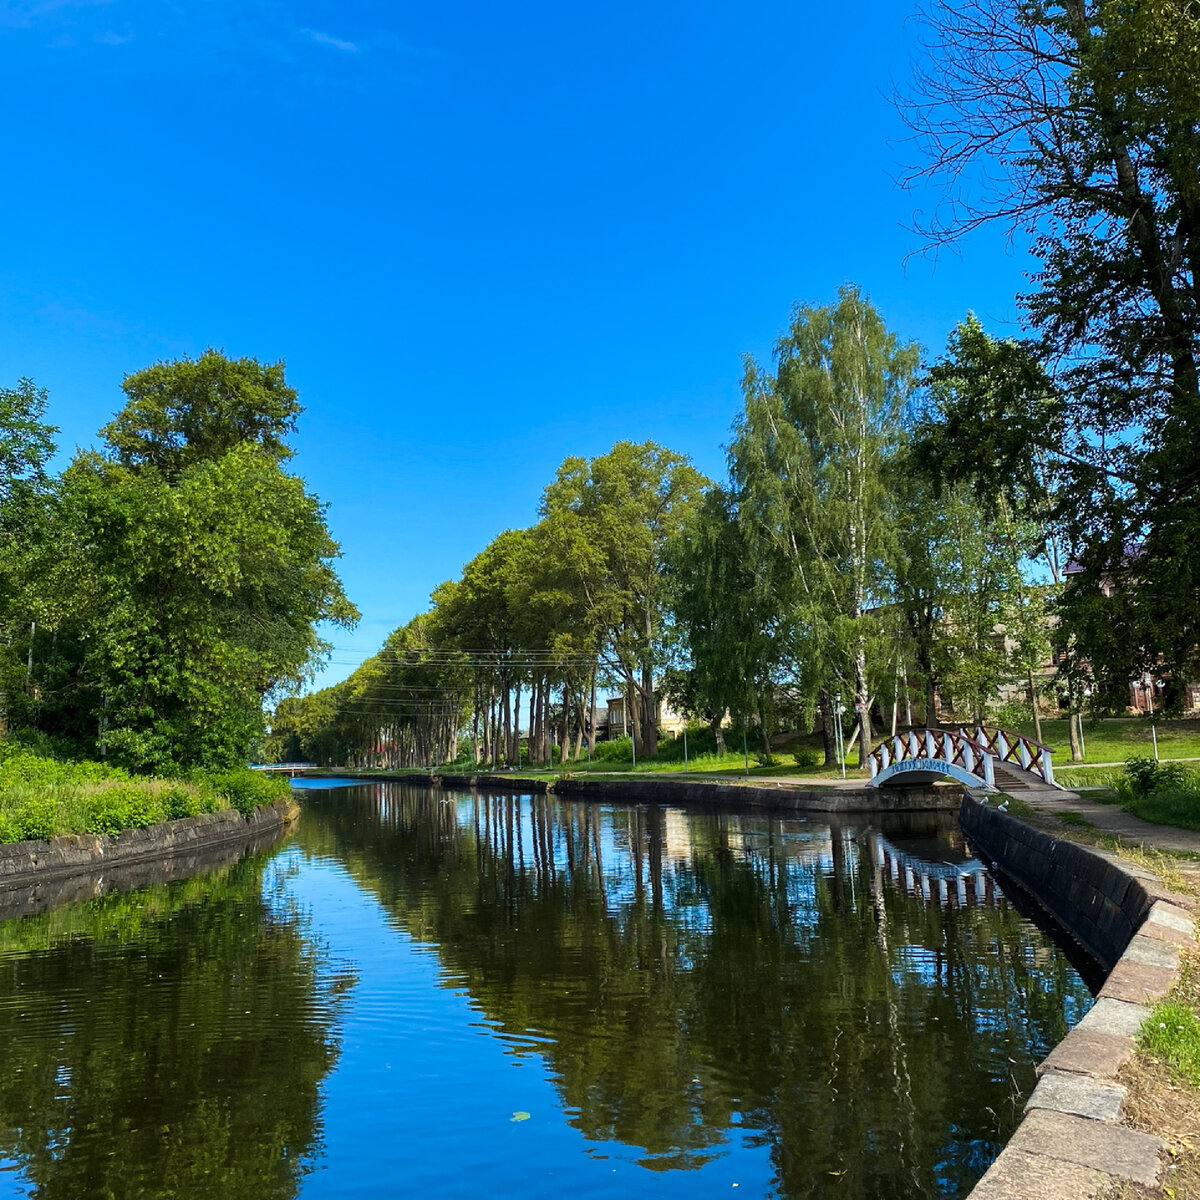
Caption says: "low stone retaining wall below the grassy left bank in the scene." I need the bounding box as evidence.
[0,799,300,889]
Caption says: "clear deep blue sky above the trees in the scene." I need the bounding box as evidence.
[0,0,1028,682]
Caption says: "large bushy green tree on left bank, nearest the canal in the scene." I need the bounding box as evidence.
[49,352,358,769]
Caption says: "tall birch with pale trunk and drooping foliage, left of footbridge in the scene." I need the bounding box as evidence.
[730,287,918,761]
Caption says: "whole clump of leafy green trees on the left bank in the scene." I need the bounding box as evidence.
[0,350,358,772]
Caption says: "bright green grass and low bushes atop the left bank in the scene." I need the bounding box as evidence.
[0,742,290,844]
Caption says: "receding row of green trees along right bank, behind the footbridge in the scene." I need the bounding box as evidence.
[274,288,1057,766]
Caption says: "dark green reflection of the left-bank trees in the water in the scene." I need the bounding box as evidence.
[0,854,353,1200]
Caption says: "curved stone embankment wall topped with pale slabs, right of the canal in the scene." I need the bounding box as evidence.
[961,796,1198,1200]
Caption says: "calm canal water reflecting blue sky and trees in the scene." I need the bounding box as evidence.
[0,784,1091,1200]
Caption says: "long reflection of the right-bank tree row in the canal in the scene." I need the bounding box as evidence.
[300,785,1088,1200]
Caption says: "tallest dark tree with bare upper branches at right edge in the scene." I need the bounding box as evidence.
[907,0,1200,698]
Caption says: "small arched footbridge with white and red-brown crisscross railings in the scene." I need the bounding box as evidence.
[868,725,1058,791]
